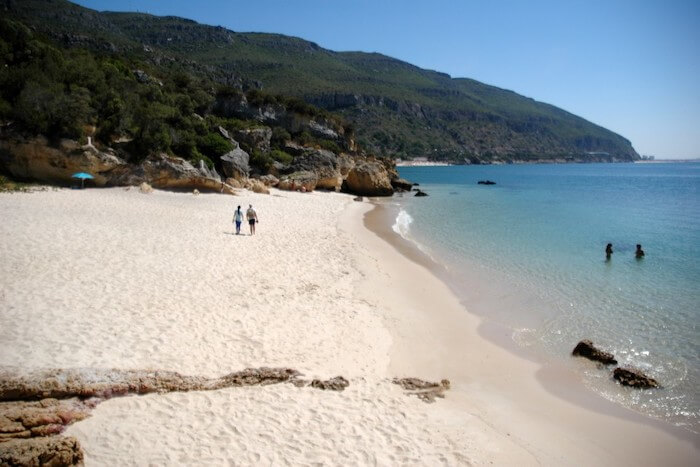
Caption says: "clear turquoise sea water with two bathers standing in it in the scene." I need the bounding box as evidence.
[392,163,700,432]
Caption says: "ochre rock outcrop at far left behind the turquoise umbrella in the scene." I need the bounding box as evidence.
[0,135,127,186]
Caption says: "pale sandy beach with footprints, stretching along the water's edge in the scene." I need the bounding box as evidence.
[0,188,700,465]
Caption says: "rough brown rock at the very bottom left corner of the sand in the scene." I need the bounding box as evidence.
[0,436,83,467]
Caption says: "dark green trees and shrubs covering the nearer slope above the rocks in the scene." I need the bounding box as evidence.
[0,18,345,176]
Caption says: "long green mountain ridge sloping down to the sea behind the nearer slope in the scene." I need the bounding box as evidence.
[0,0,639,162]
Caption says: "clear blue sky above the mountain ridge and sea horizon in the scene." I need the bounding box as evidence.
[77,0,700,158]
